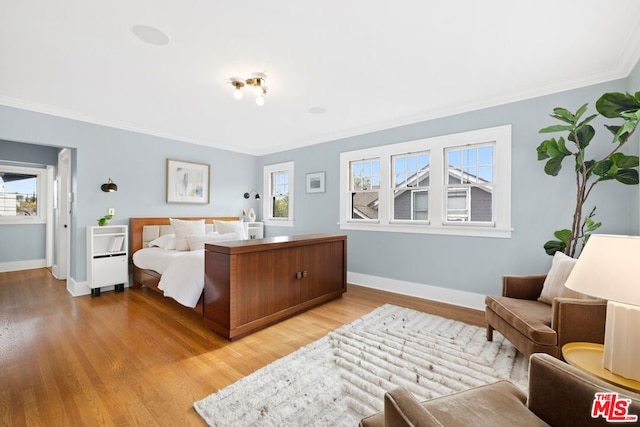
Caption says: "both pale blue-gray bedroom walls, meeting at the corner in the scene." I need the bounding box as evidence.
[0,67,640,294]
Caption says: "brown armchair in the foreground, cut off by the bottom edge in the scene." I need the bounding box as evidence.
[360,353,640,427]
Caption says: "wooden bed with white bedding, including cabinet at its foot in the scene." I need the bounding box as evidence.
[130,217,347,340]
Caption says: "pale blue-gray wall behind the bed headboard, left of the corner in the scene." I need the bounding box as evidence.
[0,106,259,281]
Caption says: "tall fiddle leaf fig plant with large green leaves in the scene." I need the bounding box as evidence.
[537,92,640,257]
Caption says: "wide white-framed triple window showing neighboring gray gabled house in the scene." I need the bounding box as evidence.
[340,125,511,237]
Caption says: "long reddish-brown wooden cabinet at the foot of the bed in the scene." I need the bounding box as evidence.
[203,234,347,340]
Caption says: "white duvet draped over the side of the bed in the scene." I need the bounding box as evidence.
[133,248,204,308]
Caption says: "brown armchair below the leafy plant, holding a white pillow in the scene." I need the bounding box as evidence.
[485,275,607,359]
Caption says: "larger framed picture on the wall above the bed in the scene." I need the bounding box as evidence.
[167,159,209,204]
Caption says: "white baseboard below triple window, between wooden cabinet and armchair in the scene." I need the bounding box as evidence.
[347,271,485,311]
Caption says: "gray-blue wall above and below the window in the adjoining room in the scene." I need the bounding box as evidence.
[0,140,58,263]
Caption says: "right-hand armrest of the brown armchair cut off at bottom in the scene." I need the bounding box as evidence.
[527,353,640,426]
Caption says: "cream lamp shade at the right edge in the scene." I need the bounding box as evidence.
[565,234,640,306]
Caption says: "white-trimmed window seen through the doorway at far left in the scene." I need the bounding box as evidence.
[0,164,47,224]
